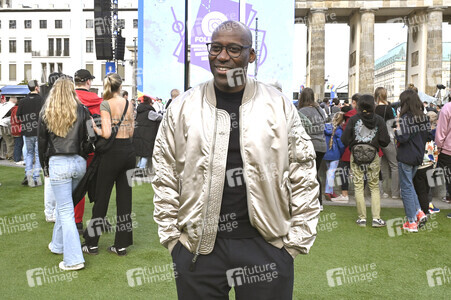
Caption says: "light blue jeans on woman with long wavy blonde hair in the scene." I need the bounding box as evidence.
[49,155,86,266]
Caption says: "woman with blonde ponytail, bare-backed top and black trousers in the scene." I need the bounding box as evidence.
[82,73,135,256]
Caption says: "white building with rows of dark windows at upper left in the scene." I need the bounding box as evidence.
[0,0,138,95]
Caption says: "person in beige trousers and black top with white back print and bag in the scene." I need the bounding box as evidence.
[341,94,390,227]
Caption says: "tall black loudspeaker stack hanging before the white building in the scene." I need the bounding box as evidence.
[94,0,113,60]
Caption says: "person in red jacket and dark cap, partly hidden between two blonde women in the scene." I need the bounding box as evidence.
[74,69,103,234]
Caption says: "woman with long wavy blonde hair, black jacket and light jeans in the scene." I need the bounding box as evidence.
[38,77,90,270]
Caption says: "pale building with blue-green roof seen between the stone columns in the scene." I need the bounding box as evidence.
[374,43,451,102]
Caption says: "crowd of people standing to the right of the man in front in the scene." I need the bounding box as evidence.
[298,85,451,232]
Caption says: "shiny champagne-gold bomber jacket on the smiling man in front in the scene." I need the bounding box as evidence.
[152,78,320,258]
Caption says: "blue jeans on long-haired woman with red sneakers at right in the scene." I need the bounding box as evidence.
[398,161,421,223]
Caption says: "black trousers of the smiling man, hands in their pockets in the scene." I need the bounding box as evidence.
[171,237,294,300]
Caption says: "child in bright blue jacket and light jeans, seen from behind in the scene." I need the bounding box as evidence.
[324,112,345,201]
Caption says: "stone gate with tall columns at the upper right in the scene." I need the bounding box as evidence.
[295,0,451,99]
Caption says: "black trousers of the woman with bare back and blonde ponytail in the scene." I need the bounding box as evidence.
[83,139,135,248]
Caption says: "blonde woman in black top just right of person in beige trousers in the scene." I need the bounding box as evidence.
[374,87,400,199]
